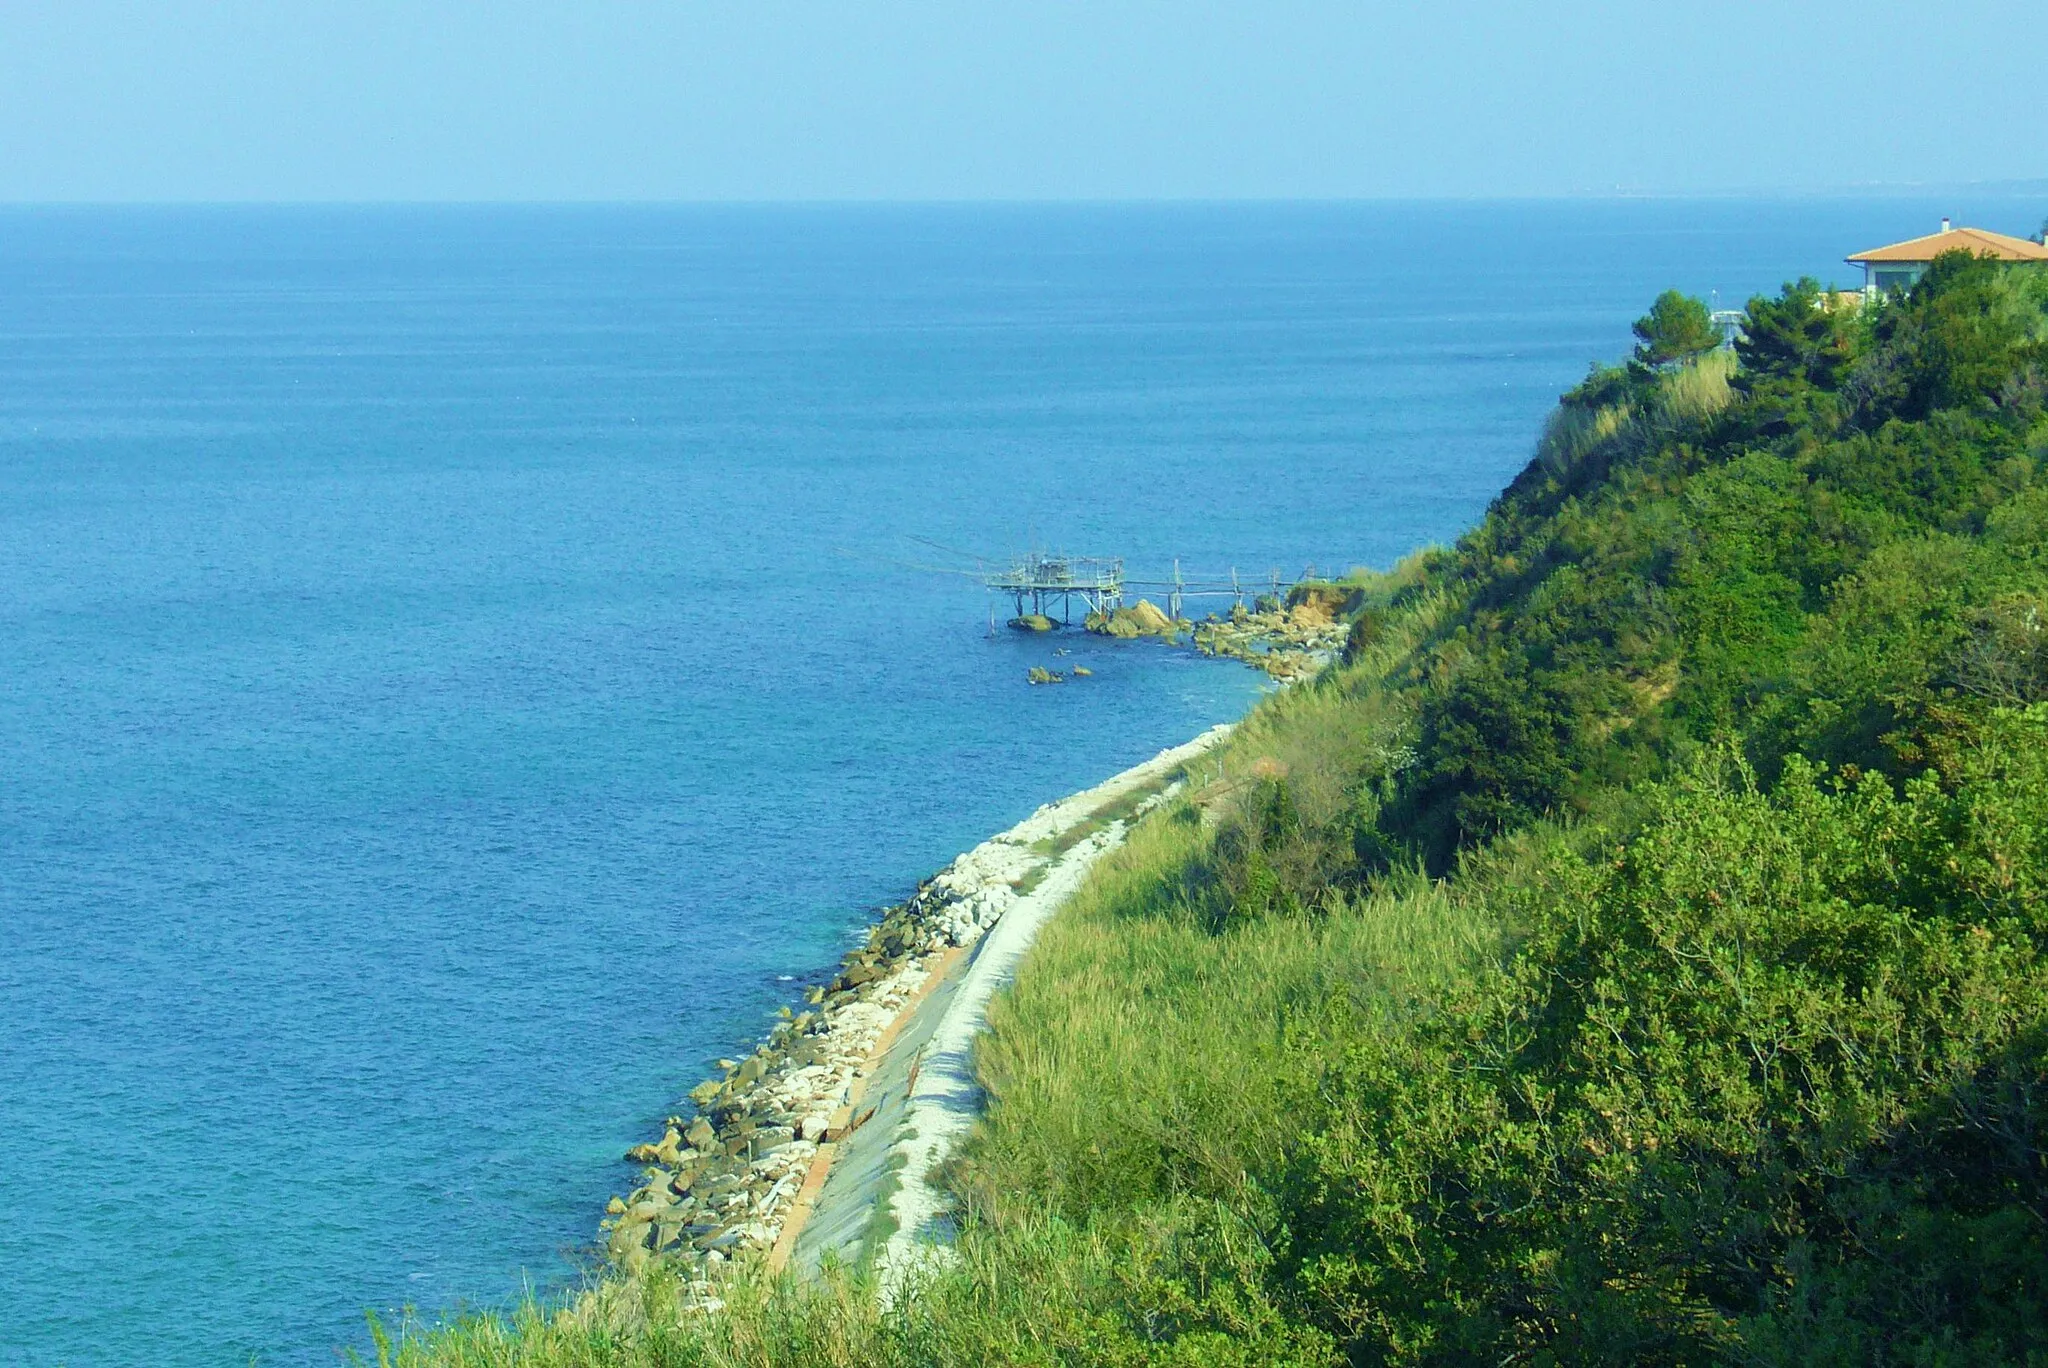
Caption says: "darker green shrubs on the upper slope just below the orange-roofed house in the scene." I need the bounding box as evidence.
[1384,254,2048,870]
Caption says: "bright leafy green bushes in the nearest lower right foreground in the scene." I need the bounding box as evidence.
[1288,709,2048,1362]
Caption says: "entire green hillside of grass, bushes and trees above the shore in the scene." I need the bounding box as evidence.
[385,256,2048,1366]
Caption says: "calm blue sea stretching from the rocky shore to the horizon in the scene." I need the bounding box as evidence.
[0,201,2015,1368]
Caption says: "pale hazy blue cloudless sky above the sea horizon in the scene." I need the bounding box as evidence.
[0,0,2048,201]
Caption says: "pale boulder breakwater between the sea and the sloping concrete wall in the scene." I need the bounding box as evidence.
[602,806,1047,1296]
